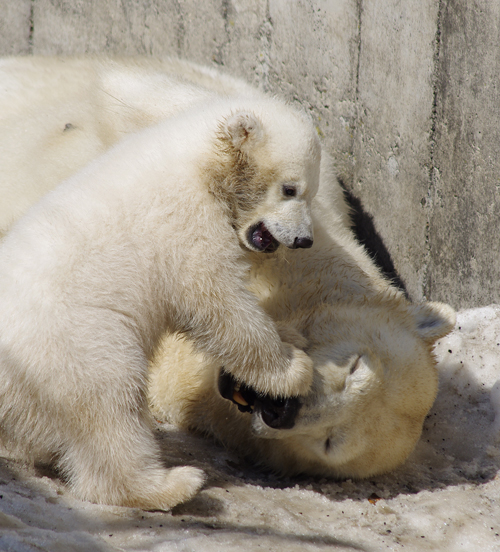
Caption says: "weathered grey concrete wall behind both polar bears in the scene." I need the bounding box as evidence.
[0,0,500,308]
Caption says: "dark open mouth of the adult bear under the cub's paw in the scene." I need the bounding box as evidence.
[218,369,301,429]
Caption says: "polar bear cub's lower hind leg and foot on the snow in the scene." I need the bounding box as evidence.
[59,411,205,510]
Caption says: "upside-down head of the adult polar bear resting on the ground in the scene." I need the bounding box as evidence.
[245,301,455,478]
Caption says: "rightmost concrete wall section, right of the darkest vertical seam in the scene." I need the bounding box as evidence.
[426,0,500,306]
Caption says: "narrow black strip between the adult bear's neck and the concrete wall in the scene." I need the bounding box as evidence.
[339,180,410,299]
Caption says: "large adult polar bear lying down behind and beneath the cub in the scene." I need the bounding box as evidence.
[0,58,454,484]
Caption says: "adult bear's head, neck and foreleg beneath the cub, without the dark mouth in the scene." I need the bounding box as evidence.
[150,178,455,478]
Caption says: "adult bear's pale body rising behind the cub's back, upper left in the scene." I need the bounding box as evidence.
[0,57,265,237]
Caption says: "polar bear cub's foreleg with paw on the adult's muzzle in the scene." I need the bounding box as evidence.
[181,265,313,397]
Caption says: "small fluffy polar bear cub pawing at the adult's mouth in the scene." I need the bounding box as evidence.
[0,98,320,509]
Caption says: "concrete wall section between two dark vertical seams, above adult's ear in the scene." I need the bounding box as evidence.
[352,0,437,300]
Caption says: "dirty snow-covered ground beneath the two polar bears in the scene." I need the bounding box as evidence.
[0,306,500,552]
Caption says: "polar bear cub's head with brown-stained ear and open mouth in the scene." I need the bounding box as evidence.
[211,102,321,253]
